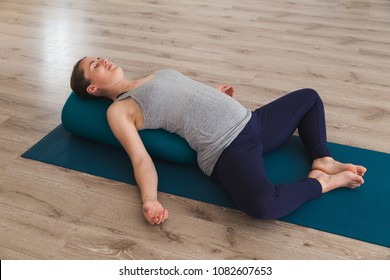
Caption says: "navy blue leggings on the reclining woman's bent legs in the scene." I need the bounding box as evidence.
[211,89,330,219]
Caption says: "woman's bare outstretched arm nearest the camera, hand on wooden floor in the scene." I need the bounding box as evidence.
[107,102,168,224]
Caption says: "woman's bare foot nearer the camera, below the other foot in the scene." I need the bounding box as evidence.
[308,170,364,193]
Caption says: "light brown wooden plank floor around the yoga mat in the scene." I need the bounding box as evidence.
[0,0,390,259]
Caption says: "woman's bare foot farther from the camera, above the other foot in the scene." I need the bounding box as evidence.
[312,157,367,176]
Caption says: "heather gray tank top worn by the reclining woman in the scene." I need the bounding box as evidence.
[115,70,251,176]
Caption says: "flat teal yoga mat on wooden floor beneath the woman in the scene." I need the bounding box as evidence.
[22,125,390,247]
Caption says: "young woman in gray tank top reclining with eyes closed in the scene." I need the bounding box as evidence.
[71,57,366,224]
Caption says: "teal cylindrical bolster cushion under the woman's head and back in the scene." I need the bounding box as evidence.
[61,92,196,164]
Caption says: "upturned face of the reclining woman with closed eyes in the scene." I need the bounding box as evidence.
[80,57,124,95]
